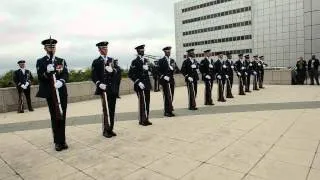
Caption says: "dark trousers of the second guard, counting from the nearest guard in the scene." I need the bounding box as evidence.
[101,93,117,133]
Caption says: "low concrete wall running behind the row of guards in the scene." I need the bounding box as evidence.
[0,70,291,113]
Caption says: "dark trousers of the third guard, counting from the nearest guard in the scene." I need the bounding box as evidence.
[136,89,150,123]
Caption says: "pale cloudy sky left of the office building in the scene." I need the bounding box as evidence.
[0,0,179,73]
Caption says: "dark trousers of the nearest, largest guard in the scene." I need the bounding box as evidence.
[47,94,68,144]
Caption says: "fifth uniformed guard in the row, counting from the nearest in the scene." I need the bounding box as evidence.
[181,49,199,110]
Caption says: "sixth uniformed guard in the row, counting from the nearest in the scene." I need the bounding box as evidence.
[199,50,214,105]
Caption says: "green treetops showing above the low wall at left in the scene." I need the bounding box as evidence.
[0,68,128,88]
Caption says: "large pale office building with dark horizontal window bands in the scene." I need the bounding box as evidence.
[175,0,320,67]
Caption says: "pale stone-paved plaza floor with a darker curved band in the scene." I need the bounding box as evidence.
[0,85,320,180]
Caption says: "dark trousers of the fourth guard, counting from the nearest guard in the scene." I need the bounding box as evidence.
[161,81,175,113]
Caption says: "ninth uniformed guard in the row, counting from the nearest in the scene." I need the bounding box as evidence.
[235,54,246,95]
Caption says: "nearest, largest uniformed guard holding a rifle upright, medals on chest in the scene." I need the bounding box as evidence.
[36,38,69,151]
